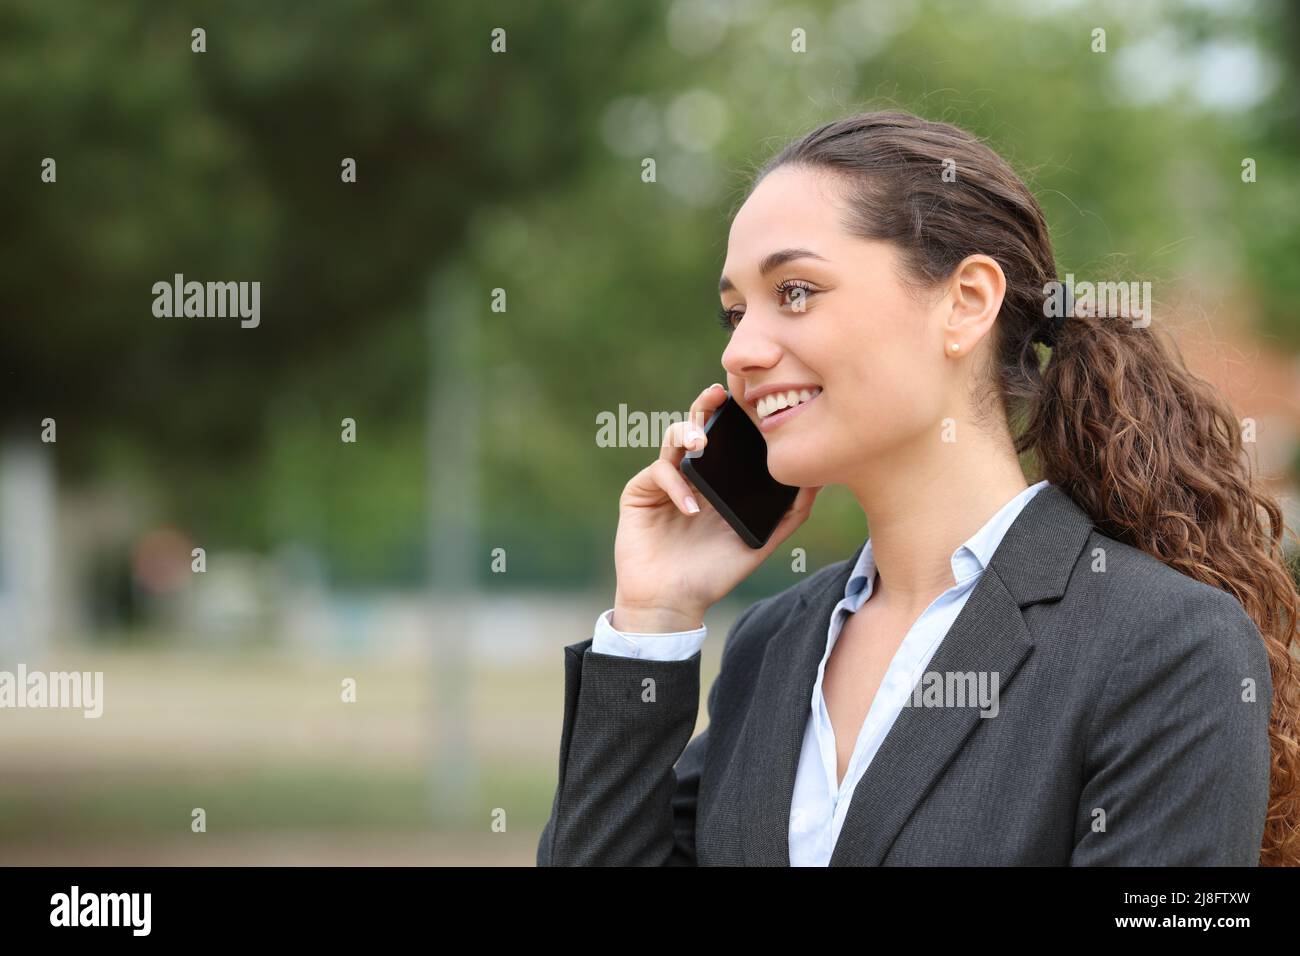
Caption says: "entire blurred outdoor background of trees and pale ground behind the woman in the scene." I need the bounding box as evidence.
[0,0,1300,865]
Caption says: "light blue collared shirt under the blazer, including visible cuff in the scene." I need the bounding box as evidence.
[592,481,1048,866]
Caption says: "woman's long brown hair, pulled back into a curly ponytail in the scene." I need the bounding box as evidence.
[750,111,1300,866]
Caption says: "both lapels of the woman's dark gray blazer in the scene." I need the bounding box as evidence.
[736,485,1092,866]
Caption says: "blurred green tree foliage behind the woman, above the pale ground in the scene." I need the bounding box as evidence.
[0,0,1300,593]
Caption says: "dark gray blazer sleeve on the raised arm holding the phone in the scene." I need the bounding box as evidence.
[537,602,762,866]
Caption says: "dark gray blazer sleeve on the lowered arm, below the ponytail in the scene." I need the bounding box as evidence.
[1070,585,1273,866]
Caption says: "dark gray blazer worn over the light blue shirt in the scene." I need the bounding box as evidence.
[537,485,1273,866]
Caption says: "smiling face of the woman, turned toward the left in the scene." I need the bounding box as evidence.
[720,166,954,486]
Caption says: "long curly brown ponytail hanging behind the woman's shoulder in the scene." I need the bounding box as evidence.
[1017,300,1300,866]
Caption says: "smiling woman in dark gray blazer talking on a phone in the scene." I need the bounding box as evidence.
[537,112,1300,865]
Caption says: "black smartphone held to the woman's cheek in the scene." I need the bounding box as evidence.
[680,395,800,548]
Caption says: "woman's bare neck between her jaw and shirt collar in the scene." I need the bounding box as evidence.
[846,421,1028,610]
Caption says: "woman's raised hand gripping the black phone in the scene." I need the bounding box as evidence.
[612,385,822,633]
